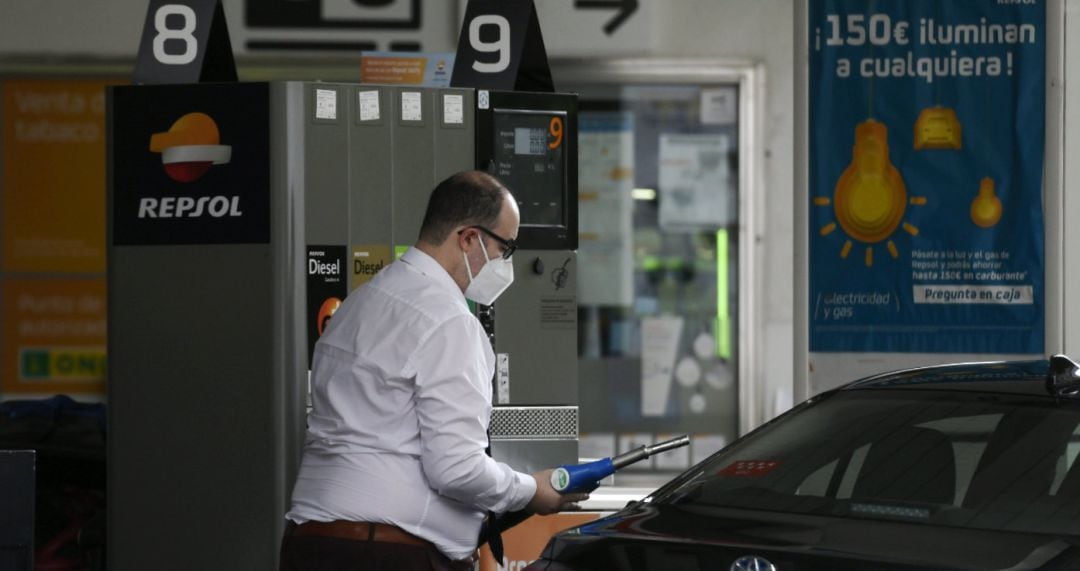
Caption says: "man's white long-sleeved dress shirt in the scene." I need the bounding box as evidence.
[286,248,536,559]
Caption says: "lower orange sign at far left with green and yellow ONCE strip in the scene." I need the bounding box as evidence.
[0,278,106,396]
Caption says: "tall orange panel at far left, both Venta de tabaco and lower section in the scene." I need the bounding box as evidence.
[0,79,117,398]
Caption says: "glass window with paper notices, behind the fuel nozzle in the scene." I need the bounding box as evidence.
[553,64,741,486]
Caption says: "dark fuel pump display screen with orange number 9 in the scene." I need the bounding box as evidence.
[495,109,567,227]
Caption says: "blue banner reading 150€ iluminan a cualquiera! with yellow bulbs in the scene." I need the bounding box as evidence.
[809,0,1047,353]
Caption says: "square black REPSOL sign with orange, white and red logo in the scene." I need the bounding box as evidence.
[107,83,273,246]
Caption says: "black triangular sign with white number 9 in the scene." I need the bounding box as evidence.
[450,0,555,92]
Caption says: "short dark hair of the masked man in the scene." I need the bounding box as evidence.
[420,171,510,245]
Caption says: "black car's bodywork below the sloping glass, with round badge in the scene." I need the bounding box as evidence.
[530,503,1080,571]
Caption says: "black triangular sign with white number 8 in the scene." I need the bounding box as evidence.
[132,0,237,83]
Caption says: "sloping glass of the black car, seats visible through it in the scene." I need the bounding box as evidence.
[654,390,1080,534]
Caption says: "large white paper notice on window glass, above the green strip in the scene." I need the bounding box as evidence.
[660,134,738,229]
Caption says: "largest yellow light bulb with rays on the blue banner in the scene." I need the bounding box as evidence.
[814,119,927,268]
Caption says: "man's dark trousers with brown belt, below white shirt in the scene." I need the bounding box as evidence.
[280,522,473,571]
